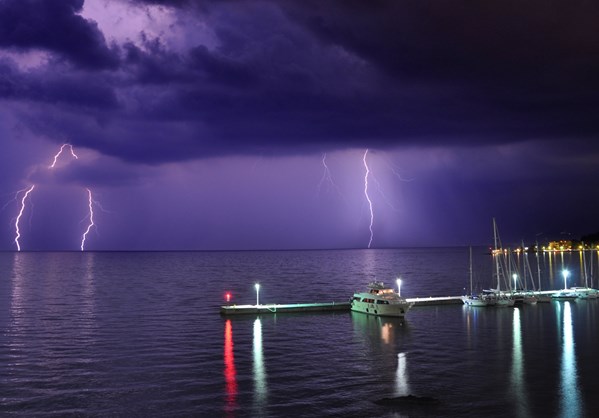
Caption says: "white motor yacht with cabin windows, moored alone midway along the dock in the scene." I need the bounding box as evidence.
[351,281,414,318]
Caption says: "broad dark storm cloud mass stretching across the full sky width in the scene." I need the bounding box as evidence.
[0,0,599,163]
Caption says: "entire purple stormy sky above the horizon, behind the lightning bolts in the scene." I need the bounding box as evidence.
[0,0,599,250]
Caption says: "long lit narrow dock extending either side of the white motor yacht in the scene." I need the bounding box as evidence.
[220,296,464,315]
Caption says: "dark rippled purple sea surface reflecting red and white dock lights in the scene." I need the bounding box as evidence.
[0,248,599,417]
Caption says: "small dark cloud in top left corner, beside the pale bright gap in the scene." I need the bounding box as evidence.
[0,0,118,70]
